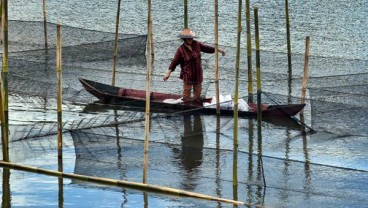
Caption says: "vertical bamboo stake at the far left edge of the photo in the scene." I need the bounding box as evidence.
[1,0,9,161]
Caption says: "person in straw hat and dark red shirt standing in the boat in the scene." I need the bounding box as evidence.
[164,28,225,102]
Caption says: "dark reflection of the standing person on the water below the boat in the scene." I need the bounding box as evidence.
[177,115,203,190]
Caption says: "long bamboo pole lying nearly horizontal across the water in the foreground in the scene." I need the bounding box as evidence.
[0,161,250,205]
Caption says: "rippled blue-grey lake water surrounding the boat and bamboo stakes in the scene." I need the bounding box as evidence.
[1,0,368,207]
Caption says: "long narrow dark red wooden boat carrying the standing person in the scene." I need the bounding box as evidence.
[79,78,305,117]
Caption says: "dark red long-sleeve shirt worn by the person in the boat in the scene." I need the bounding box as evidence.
[169,40,215,84]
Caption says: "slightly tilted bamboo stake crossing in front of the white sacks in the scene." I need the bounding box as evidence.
[233,0,242,190]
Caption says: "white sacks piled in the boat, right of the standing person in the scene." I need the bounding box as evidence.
[203,95,249,111]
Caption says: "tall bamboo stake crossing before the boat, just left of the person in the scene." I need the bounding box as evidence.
[143,0,153,183]
